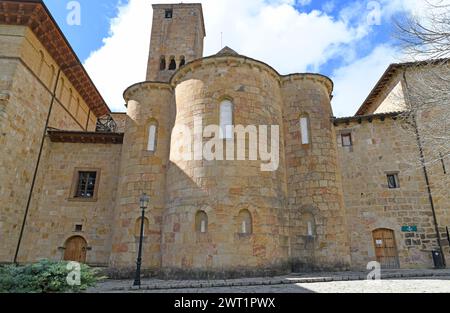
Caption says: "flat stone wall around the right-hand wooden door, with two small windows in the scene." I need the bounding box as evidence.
[336,118,437,268]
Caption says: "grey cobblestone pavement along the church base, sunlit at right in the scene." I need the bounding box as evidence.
[88,269,450,293]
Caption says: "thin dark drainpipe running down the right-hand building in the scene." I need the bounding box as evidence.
[403,69,446,267]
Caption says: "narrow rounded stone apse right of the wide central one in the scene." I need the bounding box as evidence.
[283,74,350,269]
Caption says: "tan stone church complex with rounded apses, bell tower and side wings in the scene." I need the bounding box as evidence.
[0,0,450,274]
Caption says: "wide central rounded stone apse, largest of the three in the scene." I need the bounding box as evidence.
[162,57,288,271]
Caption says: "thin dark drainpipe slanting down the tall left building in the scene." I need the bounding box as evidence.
[13,64,78,265]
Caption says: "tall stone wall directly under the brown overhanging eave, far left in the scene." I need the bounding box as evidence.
[0,25,100,262]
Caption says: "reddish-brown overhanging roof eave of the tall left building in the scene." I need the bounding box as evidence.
[0,0,111,117]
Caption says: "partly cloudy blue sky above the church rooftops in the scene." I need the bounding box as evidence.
[40,0,420,116]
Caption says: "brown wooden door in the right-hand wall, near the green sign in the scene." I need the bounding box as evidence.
[373,229,400,269]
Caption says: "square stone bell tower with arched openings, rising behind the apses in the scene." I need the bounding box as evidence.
[147,3,206,82]
